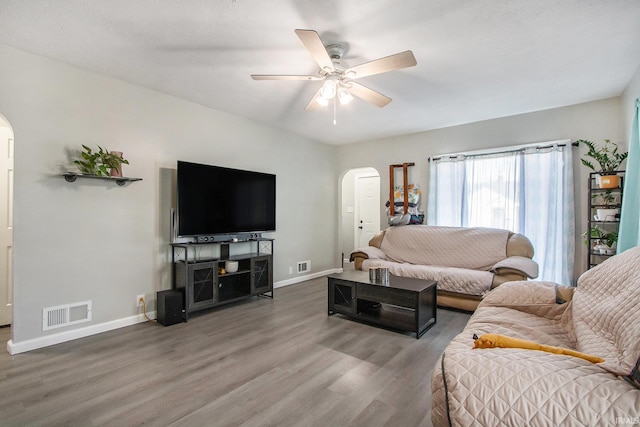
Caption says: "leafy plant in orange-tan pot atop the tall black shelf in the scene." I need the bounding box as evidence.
[576,139,629,188]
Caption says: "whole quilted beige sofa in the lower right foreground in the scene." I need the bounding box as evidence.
[431,247,640,426]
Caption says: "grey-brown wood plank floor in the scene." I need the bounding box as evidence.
[0,278,469,426]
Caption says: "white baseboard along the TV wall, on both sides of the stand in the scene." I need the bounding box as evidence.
[7,268,342,355]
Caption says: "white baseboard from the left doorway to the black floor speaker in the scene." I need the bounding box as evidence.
[7,311,156,355]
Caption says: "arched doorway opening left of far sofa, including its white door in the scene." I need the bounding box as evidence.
[340,168,381,262]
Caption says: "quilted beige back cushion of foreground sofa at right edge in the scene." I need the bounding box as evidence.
[572,247,640,375]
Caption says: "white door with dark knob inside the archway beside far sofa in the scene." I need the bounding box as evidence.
[354,175,380,248]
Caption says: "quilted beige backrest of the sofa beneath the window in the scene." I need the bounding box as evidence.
[380,225,510,270]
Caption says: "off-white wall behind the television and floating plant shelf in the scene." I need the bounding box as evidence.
[0,46,340,350]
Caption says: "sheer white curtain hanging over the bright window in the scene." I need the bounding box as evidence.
[427,141,575,285]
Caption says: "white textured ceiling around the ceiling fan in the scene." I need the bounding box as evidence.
[0,0,640,144]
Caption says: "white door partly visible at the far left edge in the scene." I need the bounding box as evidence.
[0,123,13,325]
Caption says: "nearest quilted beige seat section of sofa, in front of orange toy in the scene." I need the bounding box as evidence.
[432,338,640,426]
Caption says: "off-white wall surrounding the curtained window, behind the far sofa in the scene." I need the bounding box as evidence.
[338,98,626,277]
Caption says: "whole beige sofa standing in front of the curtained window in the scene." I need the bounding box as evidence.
[350,225,538,311]
